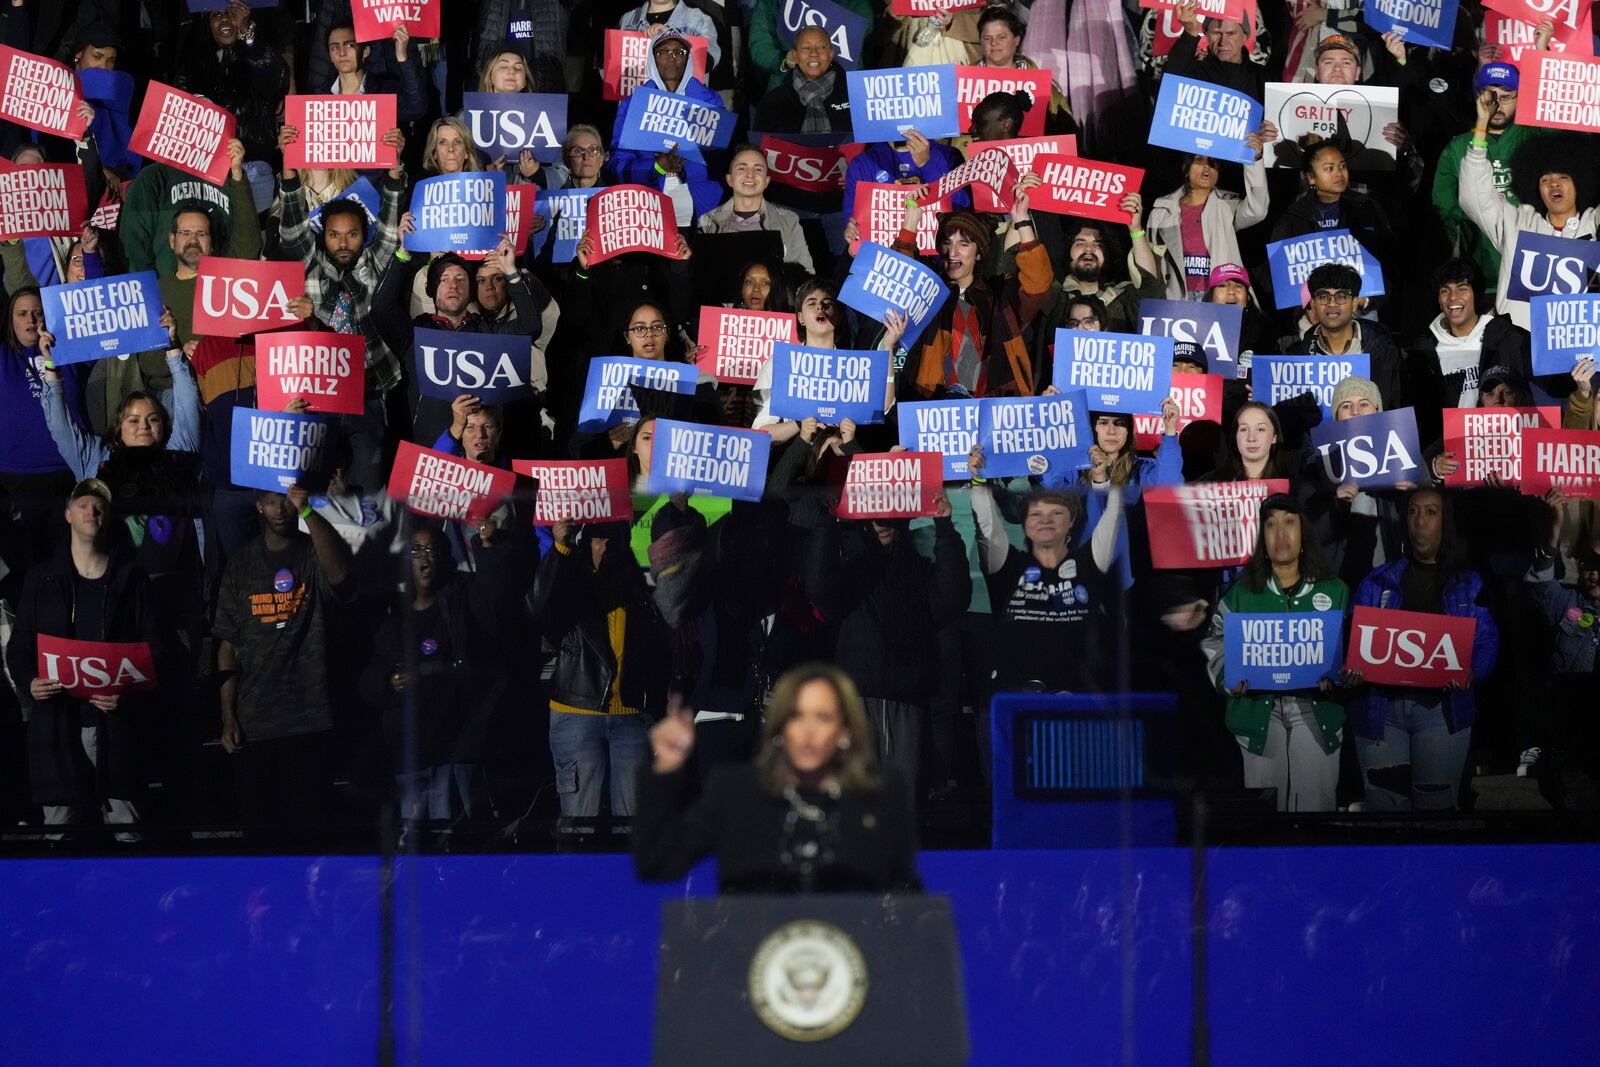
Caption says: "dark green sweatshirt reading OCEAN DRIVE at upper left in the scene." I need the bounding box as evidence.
[117,163,261,275]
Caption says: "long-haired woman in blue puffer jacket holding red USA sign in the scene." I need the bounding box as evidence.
[1346,490,1499,811]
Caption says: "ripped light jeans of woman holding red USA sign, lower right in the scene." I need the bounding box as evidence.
[1355,696,1472,811]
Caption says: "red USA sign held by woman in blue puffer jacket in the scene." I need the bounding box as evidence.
[1344,608,1478,688]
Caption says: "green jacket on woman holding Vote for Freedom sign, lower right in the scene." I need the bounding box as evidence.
[1200,577,1350,755]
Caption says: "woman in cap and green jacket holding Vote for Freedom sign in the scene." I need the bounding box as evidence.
[1200,493,1350,811]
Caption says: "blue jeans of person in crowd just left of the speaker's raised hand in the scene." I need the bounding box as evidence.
[550,707,650,816]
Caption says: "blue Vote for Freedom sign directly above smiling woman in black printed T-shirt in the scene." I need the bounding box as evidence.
[978,390,1093,478]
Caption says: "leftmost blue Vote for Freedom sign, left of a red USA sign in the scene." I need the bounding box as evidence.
[38,270,171,365]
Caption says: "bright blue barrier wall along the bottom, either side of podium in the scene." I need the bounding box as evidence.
[0,846,1600,1067]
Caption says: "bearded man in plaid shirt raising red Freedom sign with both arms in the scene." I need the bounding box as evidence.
[278,126,410,486]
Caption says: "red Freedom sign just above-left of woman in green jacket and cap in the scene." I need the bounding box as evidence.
[1144,478,1290,569]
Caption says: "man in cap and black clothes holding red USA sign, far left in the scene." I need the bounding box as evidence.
[6,478,162,840]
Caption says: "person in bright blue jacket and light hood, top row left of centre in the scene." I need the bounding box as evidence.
[611,30,722,229]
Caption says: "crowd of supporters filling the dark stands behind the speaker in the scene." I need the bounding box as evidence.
[0,0,1600,844]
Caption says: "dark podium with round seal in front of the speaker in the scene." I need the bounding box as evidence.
[651,894,970,1067]
